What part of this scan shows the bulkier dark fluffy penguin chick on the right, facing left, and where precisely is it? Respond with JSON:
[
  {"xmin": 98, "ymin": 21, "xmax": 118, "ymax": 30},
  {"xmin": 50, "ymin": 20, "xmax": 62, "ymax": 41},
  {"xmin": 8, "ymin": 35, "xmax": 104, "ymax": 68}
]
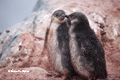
[{"xmin": 66, "ymin": 12, "xmax": 107, "ymax": 80}]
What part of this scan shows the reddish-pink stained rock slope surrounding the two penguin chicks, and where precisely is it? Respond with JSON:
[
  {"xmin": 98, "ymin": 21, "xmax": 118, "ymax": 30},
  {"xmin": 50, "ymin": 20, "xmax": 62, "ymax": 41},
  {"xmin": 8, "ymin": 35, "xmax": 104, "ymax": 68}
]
[{"xmin": 0, "ymin": 0, "xmax": 120, "ymax": 80}]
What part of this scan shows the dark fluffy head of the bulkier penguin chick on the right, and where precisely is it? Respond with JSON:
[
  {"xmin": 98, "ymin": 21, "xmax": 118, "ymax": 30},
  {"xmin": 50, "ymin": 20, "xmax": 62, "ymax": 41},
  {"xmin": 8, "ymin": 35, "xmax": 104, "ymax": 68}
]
[{"xmin": 66, "ymin": 12, "xmax": 89, "ymax": 25}]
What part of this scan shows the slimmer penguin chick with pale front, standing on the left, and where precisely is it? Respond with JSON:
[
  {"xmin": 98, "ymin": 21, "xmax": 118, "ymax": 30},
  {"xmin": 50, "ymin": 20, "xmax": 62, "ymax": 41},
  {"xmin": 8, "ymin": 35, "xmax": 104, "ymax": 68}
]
[{"xmin": 46, "ymin": 10, "xmax": 75, "ymax": 80}]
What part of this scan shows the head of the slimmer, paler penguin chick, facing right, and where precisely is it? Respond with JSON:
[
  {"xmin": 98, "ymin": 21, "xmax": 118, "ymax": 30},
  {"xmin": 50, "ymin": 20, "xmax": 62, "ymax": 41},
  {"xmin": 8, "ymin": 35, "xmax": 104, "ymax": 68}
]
[{"xmin": 52, "ymin": 10, "xmax": 66, "ymax": 24}]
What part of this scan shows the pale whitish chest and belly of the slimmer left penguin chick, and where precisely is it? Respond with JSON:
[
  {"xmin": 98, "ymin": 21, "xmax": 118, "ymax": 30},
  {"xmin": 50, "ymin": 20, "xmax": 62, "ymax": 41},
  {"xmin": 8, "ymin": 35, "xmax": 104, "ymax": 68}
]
[{"xmin": 48, "ymin": 23, "xmax": 63, "ymax": 72}]
